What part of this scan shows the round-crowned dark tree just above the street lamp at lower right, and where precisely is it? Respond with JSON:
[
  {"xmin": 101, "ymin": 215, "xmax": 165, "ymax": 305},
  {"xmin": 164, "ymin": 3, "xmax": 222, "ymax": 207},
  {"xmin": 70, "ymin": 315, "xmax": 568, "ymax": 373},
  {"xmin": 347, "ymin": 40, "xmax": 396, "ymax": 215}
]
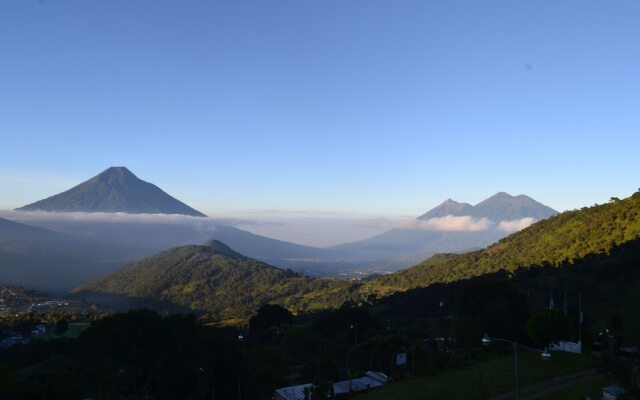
[{"xmin": 527, "ymin": 309, "xmax": 573, "ymax": 347}]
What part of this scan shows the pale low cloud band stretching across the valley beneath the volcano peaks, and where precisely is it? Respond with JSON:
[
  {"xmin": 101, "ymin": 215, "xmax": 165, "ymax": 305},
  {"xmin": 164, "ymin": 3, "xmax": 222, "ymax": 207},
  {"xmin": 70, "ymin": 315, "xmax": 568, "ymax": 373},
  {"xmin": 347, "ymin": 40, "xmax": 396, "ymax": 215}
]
[{"xmin": 0, "ymin": 210, "xmax": 536, "ymax": 247}]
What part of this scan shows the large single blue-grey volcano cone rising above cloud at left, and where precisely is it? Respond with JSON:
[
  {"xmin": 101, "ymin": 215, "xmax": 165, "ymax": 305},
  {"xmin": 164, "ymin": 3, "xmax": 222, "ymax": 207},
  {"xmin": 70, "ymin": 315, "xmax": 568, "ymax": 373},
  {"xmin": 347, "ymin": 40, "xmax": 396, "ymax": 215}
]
[{"xmin": 17, "ymin": 167, "xmax": 206, "ymax": 217}]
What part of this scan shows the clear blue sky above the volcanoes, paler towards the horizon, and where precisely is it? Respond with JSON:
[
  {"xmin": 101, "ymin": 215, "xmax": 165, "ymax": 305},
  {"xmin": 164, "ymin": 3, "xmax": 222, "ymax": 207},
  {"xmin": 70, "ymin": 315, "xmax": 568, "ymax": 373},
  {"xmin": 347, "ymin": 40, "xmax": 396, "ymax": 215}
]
[{"xmin": 0, "ymin": 0, "xmax": 640, "ymax": 222}]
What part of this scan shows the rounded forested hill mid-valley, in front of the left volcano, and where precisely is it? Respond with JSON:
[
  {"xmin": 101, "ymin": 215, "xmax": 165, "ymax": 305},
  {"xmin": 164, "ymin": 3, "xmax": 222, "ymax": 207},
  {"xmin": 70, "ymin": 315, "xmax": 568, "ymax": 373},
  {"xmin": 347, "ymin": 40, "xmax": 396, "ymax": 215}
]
[{"xmin": 75, "ymin": 241, "xmax": 355, "ymax": 322}]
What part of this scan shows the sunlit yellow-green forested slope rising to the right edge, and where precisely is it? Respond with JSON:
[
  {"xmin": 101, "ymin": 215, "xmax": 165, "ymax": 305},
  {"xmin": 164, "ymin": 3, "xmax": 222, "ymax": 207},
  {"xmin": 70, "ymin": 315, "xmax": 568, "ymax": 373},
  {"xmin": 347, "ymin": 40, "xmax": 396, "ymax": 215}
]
[{"xmin": 362, "ymin": 192, "xmax": 640, "ymax": 295}]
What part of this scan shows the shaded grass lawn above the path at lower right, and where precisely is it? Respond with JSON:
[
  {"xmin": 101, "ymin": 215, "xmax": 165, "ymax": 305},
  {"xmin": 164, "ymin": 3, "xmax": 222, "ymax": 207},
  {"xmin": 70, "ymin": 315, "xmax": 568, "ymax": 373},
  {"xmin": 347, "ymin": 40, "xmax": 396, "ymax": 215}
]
[{"xmin": 356, "ymin": 352, "xmax": 589, "ymax": 400}]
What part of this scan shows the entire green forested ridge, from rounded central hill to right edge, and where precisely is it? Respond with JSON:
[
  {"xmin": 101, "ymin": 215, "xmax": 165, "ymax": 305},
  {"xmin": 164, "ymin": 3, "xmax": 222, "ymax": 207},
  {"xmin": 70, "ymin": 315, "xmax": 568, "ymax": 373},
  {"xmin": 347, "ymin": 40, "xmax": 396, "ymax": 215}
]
[{"xmin": 77, "ymin": 193, "xmax": 640, "ymax": 323}]
